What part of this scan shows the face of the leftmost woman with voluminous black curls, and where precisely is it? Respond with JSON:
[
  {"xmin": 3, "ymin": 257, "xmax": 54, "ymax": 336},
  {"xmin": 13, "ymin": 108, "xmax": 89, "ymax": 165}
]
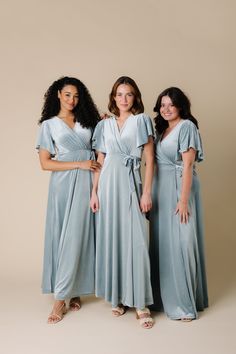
[{"xmin": 58, "ymin": 85, "xmax": 79, "ymax": 111}]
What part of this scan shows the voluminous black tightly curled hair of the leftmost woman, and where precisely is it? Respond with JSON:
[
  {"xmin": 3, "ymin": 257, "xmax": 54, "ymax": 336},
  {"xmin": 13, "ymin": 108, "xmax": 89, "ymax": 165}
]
[{"xmin": 39, "ymin": 76, "xmax": 100, "ymax": 128}]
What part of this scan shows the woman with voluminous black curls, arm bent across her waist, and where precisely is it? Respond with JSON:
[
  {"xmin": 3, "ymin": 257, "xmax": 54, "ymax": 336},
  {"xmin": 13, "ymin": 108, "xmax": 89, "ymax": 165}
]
[{"xmin": 37, "ymin": 77, "xmax": 100, "ymax": 324}]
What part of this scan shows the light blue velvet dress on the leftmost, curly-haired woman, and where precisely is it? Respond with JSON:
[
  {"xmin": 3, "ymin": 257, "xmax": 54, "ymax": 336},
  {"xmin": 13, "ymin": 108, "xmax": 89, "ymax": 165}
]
[{"xmin": 37, "ymin": 117, "xmax": 95, "ymax": 300}]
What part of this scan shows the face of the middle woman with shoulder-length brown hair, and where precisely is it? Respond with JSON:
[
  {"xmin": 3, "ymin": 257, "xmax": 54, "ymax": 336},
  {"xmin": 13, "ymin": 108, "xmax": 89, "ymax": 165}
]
[{"xmin": 114, "ymin": 84, "xmax": 135, "ymax": 113}]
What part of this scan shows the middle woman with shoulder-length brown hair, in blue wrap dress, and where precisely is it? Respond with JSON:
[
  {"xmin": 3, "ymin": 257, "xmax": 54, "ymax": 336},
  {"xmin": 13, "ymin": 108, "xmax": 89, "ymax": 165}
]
[{"xmin": 90, "ymin": 76, "xmax": 154, "ymax": 328}]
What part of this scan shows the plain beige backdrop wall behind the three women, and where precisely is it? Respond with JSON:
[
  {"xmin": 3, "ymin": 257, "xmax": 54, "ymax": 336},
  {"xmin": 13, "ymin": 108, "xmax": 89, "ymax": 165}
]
[{"xmin": 0, "ymin": 0, "xmax": 236, "ymax": 352}]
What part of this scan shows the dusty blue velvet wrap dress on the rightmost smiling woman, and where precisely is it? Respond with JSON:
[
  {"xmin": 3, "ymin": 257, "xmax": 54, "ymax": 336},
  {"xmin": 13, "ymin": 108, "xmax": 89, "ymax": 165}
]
[{"xmin": 150, "ymin": 120, "xmax": 208, "ymax": 319}]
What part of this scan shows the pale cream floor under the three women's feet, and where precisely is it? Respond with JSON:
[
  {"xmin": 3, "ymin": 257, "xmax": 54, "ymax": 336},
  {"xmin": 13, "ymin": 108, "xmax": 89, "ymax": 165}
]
[{"xmin": 0, "ymin": 278, "xmax": 236, "ymax": 354}]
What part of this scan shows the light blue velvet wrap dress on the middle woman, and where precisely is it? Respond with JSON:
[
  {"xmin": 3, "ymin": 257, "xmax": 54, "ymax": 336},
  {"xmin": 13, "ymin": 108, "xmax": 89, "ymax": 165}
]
[{"xmin": 93, "ymin": 114, "xmax": 153, "ymax": 309}]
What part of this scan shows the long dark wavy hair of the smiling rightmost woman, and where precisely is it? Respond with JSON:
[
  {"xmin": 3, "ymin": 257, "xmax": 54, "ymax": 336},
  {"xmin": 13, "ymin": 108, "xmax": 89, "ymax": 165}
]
[{"xmin": 153, "ymin": 87, "xmax": 198, "ymax": 134}]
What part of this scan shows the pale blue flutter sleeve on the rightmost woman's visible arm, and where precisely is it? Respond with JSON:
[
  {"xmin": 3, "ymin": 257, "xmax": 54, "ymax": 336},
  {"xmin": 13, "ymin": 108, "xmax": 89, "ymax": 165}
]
[{"xmin": 176, "ymin": 120, "xmax": 204, "ymax": 162}]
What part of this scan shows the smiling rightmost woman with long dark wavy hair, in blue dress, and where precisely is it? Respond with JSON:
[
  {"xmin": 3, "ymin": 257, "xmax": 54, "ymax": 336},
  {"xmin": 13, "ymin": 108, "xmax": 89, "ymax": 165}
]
[{"xmin": 150, "ymin": 87, "xmax": 208, "ymax": 321}]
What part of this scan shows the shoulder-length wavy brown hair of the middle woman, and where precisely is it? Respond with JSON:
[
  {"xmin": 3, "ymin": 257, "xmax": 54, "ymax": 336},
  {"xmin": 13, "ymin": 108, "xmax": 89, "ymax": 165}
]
[{"xmin": 108, "ymin": 76, "xmax": 144, "ymax": 116}]
